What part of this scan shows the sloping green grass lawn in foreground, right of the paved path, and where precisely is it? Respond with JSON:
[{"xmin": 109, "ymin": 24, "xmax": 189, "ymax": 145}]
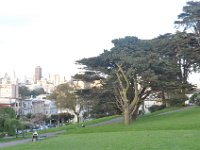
[{"xmin": 2, "ymin": 107, "xmax": 200, "ymax": 150}]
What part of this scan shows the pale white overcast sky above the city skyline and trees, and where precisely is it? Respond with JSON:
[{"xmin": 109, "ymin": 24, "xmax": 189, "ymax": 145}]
[{"xmin": 0, "ymin": 0, "xmax": 187, "ymax": 81}]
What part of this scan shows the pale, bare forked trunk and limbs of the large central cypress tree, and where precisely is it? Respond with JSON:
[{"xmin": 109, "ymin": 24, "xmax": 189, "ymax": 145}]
[{"xmin": 116, "ymin": 65, "xmax": 151, "ymax": 125}]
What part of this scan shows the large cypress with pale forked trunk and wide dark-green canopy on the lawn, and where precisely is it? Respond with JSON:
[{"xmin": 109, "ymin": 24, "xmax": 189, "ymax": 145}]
[{"xmin": 78, "ymin": 37, "xmax": 166, "ymax": 125}]
